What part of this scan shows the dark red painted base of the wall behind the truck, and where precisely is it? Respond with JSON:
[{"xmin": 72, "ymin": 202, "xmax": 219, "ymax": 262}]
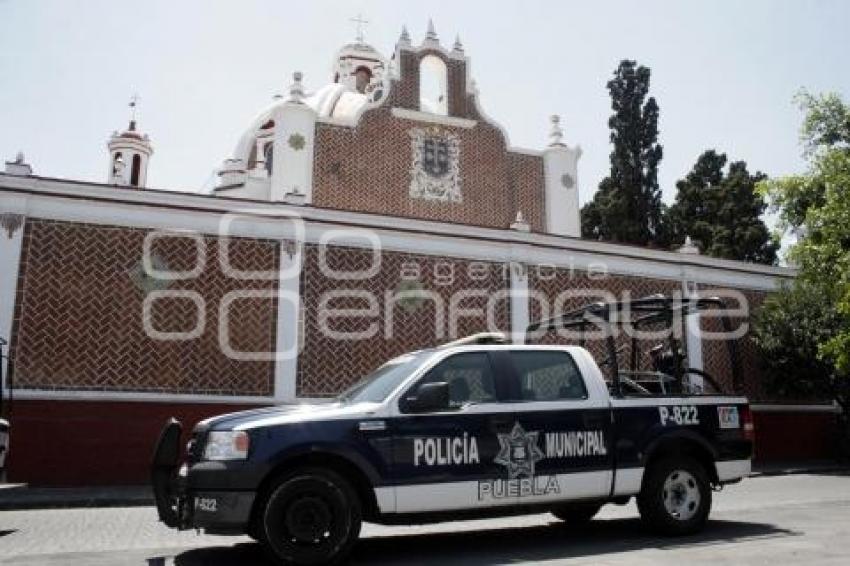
[{"xmin": 0, "ymin": 400, "xmax": 836, "ymax": 486}]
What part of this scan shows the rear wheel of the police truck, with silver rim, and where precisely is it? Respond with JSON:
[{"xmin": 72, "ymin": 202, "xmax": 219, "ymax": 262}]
[{"xmin": 637, "ymin": 456, "xmax": 711, "ymax": 535}]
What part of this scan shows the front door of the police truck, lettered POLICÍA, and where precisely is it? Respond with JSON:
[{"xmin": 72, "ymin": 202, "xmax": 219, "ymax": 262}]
[{"xmin": 392, "ymin": 351, "xmax": 512, "ymax": 513}]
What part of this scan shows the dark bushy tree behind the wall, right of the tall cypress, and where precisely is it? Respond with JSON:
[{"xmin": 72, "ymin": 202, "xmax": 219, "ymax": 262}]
[{"xmin": 667, "ymin": 149, "xmax": 779, "ymax": 264}]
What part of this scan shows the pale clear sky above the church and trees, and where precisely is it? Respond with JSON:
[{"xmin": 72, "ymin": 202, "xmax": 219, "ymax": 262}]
[{"xmin": 0, "ymin": 0, "xmax": 850, "ymax": 201}]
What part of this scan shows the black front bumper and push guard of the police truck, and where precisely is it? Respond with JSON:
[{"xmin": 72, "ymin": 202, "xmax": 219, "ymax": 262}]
[{"xmin": 151, "ymin": 419, "xmax": 255, "ymax": 534}]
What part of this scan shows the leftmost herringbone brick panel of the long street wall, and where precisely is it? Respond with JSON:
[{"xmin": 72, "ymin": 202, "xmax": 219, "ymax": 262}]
[{"xmin": 13, "ymin": 220, "xmax": 278, "ymax": 395}]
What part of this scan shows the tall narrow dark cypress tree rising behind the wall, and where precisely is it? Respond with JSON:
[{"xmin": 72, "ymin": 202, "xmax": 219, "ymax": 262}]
[{"xmin": 581, "ymin": 60, "xmax": 666, "ymax": 245}]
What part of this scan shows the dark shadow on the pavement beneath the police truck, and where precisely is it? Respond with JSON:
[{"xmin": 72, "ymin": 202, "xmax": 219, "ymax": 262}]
[{"xmin": 174, "ymin": 519, "xmax": 800, "ymax": 566}]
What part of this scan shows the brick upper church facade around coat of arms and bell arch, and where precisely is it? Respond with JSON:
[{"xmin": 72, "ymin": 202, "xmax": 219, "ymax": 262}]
[{"xmin": 313, "ymin": 46, "xmax": 545, "ymax": 232}]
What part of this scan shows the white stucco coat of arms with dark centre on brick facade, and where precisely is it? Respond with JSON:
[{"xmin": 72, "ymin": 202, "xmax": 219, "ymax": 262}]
[{"xmin": 410, "ymin": 127, "xmax": 463, "ymax": 202}]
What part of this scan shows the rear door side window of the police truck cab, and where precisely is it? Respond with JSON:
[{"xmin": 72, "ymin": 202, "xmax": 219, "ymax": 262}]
[{"xmin": 511, "ymin": 350, "xmax": 587, "ymax": 401}]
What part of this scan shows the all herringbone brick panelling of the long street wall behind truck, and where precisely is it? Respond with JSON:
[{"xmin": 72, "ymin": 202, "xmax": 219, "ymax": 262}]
[{"xmin": 4, "ymin": 220, "xmax": 780, "ymax": 400}]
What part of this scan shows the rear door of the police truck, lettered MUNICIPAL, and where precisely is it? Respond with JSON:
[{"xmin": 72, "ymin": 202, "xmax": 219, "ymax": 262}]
[{"xmin": 497, "ymin": 349, "xmax": 613, "ymax": 506}]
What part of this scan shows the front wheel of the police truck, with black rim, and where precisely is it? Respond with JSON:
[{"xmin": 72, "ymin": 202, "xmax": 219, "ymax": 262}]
[{"xmin": 262, "ymin": 468, "xmax": 361, "ymax": 564}]
